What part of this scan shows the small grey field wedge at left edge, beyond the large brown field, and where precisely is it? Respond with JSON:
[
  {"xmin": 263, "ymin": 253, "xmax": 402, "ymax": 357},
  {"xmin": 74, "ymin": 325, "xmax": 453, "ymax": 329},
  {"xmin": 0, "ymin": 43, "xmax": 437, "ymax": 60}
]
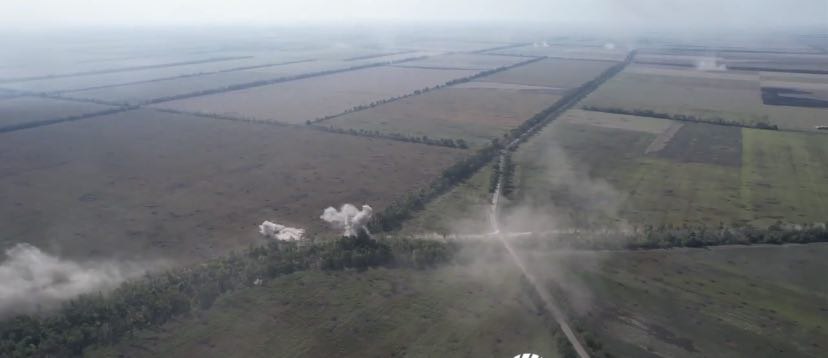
[{"xmin": 0, "ymin": 97, "xmax": 113, "ymax": 131}]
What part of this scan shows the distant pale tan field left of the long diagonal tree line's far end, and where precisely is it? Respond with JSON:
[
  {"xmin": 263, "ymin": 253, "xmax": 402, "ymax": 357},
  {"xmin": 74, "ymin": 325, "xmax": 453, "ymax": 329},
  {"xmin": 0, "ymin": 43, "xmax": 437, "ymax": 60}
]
[{"xmin": 480, "ymin": 59, "xmax": 615, "ymax": 88}]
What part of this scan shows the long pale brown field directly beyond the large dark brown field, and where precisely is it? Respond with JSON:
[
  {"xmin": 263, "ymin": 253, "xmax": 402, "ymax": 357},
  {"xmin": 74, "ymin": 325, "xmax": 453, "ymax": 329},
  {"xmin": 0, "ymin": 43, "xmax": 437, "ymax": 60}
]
[{"xmin": 151, "ymin": 67, "xmax": 476, "ymax": 123}]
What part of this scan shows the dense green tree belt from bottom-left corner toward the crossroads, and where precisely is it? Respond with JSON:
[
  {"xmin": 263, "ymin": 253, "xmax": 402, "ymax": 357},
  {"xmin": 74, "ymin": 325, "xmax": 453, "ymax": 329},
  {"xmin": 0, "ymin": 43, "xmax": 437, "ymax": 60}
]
[{"xmin": 0, "ymin": 232, "xmax": 456, "ymax": 358}]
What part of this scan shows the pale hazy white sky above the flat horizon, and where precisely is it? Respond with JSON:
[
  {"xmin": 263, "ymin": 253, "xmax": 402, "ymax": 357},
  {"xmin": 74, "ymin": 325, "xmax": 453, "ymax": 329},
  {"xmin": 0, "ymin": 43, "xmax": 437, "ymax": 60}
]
[{"xmin": 0, "ymin": 0, "xmax": 828, "ymax": 28}]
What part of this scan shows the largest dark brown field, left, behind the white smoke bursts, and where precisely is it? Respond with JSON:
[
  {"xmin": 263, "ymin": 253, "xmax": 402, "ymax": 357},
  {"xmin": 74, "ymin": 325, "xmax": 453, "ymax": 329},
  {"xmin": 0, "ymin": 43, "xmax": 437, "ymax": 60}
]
[{"xmin": 0, "ymin": 110, "xmax": 466, "ymax": 262}]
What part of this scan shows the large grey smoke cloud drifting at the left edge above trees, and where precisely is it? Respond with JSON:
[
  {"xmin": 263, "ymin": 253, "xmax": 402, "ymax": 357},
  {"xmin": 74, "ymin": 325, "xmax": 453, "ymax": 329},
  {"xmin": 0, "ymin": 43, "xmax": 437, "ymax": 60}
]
[{"xmin": 0, "ymin": 244, "xmax": 150, "ymax": 316}]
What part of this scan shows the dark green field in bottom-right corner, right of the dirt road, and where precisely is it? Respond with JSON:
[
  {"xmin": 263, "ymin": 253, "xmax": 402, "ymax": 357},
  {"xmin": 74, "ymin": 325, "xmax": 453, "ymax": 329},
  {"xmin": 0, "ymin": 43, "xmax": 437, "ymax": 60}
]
[{"xmin": 556, "ymin": 244, "xmax": 828, "ymax": 357}]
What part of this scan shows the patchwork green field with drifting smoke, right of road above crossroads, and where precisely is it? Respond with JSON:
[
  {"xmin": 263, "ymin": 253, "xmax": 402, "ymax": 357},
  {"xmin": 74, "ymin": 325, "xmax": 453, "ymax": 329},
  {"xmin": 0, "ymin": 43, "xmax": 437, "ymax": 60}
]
[{"xmin": 507, "ymin": 111, "xmax": 828, "ymax": 226}]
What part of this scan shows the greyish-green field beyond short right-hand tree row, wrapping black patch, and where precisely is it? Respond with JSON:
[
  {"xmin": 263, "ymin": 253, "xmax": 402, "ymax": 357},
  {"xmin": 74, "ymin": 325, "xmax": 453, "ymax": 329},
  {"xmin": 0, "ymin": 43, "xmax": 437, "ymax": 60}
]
[{"xmin": 585, "ymin": 65, "xmax": 828, "ymax": 131}]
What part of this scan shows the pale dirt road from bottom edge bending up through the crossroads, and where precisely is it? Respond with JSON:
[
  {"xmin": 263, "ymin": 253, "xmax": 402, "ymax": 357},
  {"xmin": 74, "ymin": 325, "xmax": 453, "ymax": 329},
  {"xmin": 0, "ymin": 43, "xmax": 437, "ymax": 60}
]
[{"xmin": 489, "ymin": 153, "xmax": 589, "ymax": 358}]
